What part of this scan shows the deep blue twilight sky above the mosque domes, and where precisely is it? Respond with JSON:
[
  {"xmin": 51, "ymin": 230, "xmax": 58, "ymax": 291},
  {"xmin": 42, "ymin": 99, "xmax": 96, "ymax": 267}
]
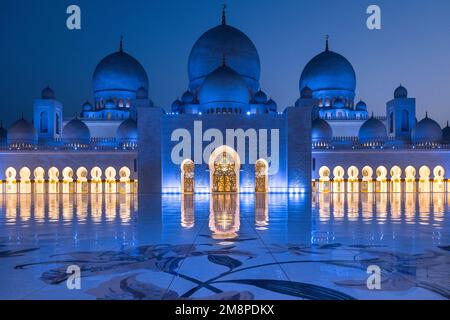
[{"xmin": 0, "ymin": 0, "xmax": 450, "ymax": 126}]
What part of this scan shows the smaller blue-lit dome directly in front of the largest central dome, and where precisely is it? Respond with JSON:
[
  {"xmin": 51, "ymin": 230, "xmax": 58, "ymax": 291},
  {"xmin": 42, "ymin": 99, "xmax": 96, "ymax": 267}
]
[{"xmin": 199, "ymin": 65, "xmax": 250, "ymax": 104}]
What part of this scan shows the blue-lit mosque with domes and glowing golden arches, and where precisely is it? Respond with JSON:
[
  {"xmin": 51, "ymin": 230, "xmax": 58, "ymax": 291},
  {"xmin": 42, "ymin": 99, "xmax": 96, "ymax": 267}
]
[{"xmin": 0, "ymin": 12, "xmax": 450, "ymax": 194}]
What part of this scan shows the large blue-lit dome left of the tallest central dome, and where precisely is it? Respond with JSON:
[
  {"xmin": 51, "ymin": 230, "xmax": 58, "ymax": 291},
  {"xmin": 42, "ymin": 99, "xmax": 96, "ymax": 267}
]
[{"xmin": 92, "ymin": 45, "xmax": 148, "ymax": 98}]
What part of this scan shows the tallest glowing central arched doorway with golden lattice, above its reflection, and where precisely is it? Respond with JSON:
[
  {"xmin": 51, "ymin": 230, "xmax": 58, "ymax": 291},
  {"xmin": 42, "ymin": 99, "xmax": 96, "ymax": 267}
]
[{"xmin": 209, "ymin": 146, "xmax": 241, "ymax": 192}]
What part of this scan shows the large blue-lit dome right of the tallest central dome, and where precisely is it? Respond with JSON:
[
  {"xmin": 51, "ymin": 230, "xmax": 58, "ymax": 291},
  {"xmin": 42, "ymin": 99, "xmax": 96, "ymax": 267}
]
[{"xmin": 300, "ymin": 50, "xmax": 356, "ymax": 93}]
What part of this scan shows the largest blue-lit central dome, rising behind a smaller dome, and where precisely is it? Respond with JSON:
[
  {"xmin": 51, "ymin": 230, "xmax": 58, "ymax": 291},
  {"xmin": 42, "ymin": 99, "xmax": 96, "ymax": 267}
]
[{"xmin": 188, "ymin": 22, "xmax": 261, "ymax": 92}]
